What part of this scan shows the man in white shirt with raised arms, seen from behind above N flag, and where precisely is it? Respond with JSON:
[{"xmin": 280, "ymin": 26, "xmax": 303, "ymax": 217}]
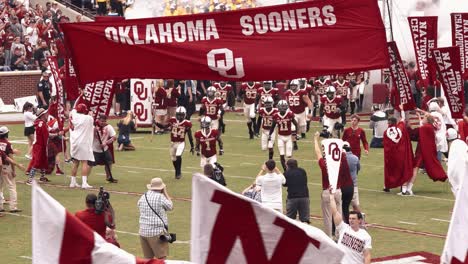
[{"xmin": 256, "ymin": 159, "xmax": 286, "ymax": 212}]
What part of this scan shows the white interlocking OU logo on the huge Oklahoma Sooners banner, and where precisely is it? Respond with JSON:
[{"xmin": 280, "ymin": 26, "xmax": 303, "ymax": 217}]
[{"xmin": 206, "ymin": 48, "xmax": 245, "ymax": 78}]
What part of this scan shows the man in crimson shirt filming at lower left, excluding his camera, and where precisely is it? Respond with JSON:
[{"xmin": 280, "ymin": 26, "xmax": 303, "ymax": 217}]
[{"xmin": 75, "ymin": 193, "xmax": 115, "ymax": 239}]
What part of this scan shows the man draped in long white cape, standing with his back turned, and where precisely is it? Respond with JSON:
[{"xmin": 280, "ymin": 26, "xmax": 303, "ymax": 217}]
[{"xmin": 70, "ymin": 104, "xmax": 94, "ymax": 189}]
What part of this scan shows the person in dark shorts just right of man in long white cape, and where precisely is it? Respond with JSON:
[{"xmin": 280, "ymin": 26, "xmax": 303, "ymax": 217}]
[{"xmin": 92, "ymin": 114, "xmax": 117, "ymax": 183}]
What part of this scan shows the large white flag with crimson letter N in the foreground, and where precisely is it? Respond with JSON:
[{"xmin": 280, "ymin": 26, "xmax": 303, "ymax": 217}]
[{"xmin": 190, "ymin": 174, "xmax": 343, "ymax": 264}]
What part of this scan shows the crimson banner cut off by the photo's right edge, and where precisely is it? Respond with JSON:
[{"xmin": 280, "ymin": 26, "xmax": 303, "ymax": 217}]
[{"xmin": 451, "ymin": 13, "xmax": 468, "ymax": 80}]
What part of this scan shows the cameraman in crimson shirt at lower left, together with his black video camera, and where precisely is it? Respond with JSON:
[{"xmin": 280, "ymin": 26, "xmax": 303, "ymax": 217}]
[{"xmin": 75, "ymin": 191, "xmax": 115, "ymax": 238}]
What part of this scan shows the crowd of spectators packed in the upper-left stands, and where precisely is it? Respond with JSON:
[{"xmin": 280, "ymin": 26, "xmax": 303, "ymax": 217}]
[{"xmin": 0, "ymin": 0, "xmax": 70, "ymax": 71}]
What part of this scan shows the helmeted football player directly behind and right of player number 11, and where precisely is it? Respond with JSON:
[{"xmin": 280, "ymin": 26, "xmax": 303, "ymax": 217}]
[{"xmin": 284, "ymin": 79, "xmax": 312, "ymax": 150}]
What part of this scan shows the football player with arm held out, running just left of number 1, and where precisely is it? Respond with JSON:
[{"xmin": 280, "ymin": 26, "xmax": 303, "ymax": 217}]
[{"xmin": 156, "ymin": 106, "xmax": 194, "ymax": 179}]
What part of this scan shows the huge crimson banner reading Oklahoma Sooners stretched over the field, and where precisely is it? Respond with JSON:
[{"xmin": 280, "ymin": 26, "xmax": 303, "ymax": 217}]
[{"xmin": 61, "ymin": 0, "xmax": 388, "ymax": 83}]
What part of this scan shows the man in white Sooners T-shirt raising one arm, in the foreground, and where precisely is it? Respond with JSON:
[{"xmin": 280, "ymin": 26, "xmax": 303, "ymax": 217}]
[{"xmin": 329, "ymin": 188, "xmax": 372, "ymax": 264}]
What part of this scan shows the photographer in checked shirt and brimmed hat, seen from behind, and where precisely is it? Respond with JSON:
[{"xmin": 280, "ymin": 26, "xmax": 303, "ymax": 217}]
[{"xmin": 138, "ymin": 178, "xmax": 175, "ymax": 259}]
